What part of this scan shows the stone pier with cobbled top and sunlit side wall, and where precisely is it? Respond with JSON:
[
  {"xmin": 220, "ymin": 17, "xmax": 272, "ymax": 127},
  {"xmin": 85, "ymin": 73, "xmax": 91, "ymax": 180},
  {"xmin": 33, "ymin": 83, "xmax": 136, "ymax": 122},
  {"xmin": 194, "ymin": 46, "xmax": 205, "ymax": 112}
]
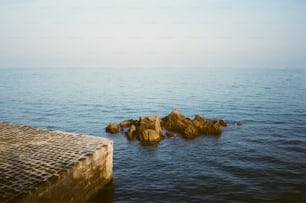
[{"xmin": 0, "ymin": 123, "xmax": 113, "ymax": 202}]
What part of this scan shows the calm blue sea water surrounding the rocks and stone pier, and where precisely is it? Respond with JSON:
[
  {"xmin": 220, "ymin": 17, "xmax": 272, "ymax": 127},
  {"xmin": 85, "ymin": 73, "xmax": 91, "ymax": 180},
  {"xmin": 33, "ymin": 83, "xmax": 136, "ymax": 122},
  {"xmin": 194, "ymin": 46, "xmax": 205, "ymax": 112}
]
[{"xmin": 0, "ymin": 68, "xmax": 306, "ymax": 202}]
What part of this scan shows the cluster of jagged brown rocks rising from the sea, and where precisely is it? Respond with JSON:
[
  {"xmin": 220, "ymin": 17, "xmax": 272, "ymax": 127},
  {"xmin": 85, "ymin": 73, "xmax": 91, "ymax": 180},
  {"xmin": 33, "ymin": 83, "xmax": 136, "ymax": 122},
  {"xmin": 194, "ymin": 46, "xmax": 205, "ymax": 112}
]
[{"xmin": 105, "ymin": 109, "xmax": 227, "ymax": 142}]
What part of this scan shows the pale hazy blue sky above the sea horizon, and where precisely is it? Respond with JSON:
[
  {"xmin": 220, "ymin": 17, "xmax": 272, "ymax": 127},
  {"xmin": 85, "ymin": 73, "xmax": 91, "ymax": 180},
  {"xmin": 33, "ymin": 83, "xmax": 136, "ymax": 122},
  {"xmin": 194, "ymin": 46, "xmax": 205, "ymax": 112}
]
[{"xmin": 0, "ymin": 0, "xmax": 306, "ymax": 67}]
